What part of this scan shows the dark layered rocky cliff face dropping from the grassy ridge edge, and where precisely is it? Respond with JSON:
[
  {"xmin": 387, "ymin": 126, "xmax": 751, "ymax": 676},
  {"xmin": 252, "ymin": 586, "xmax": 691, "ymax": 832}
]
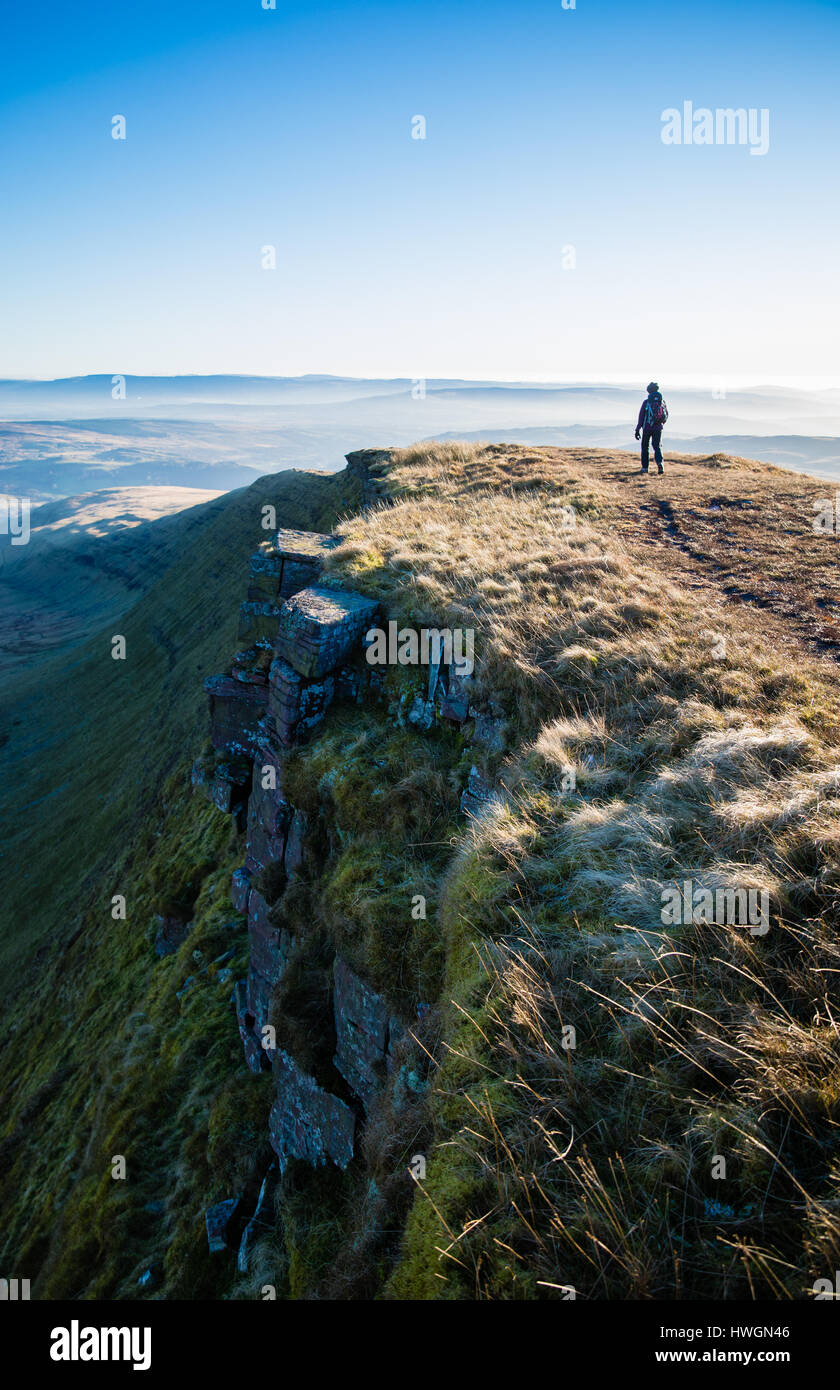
[{"xmin": 193, "ymin": 450, "xmax": 503, "ymax": 1269}]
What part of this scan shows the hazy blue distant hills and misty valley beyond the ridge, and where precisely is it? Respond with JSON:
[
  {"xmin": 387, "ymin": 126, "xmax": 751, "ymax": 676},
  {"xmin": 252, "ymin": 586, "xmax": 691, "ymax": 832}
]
[{"xmin": 0, "ymin": 374, "xmax": 840, "ymax": 502}]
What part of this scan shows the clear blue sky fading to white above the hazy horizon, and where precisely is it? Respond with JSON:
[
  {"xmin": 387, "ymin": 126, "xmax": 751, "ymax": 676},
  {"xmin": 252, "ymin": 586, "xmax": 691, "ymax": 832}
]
[{"xmin": 0, "ymin": 0, "xmax": 840, "ymax": 384}]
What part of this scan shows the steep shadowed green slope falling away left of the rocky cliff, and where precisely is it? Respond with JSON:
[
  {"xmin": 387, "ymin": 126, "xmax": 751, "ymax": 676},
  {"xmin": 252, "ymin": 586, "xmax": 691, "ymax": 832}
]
[{"xmin": 0, "ymin": 473, "xmax": 357, "ymax": 1297}]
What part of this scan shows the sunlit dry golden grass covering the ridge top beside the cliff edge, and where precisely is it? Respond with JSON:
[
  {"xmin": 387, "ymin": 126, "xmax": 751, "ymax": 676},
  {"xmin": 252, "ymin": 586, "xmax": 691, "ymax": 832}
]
[{"xmin": 332, "ymin": 445, "xmax": 840, "ymax": 1298}]
